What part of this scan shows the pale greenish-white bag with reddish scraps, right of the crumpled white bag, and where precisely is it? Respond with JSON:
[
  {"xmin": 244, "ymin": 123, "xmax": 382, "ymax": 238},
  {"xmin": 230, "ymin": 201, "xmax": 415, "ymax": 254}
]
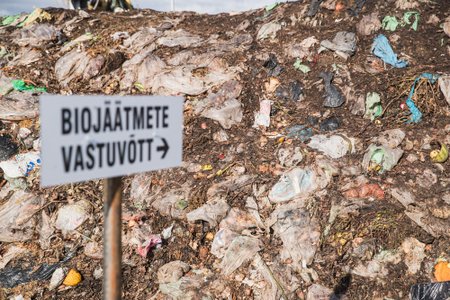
[{"xmin": 362, "ymin": 144, "xmax": 403, "ymax": 173}]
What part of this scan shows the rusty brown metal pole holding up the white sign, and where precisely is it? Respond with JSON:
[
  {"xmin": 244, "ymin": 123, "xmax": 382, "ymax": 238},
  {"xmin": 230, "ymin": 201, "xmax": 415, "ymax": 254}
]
[{"xmin": 103, "ymin": 177, "xmax": 122, "ymax": 300}]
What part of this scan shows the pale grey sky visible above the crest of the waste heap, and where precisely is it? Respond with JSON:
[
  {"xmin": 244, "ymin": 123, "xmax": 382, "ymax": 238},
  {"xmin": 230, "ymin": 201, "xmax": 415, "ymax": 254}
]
[{"xmin": 0, "ymin": 0, "xmax": 294, "ymax": 16}]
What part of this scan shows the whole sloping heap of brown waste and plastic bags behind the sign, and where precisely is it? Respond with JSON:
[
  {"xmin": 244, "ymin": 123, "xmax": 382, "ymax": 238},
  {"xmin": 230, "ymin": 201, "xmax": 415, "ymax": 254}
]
[{"xmin": 0, "ymin": 0, "xmax": 450, "ymax": 300}]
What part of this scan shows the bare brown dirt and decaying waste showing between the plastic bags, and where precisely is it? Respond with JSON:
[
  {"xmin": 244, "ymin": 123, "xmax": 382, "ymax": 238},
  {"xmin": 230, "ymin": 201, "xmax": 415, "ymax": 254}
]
[{"xmin": 0, "ymin": 0, "xmax": 450, "ymax": 299}]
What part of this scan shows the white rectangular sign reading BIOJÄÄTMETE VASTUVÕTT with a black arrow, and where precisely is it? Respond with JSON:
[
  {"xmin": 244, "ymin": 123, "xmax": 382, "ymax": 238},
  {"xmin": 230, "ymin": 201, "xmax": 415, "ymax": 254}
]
[{"xmin": 40, "ymin": 95, "xmax": 183, "ymax": 186}]
